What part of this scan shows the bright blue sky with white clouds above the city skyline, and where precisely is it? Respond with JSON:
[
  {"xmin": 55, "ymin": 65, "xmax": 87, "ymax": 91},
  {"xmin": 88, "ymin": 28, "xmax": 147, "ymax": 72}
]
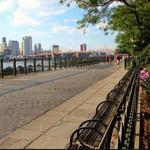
[{"xmin": 0, "ymin": 0, "xmax": 116, "ymax": 50}]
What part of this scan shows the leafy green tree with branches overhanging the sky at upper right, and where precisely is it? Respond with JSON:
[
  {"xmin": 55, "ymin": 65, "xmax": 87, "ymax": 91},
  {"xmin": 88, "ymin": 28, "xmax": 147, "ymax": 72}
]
[{"xmin": 60, "ymin": 0, "xmax": 150, "ymax": 54}]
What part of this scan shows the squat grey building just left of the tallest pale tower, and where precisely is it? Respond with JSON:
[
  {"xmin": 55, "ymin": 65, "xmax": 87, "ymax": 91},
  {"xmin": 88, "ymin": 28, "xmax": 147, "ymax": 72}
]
[{"xmin": 8, "ymin": 41, "xmax": 19, "ymax": 56}]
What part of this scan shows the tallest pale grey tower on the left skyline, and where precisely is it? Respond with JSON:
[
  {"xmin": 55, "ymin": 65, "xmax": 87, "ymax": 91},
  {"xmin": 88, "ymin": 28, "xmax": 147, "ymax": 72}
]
[{"xmin": 22, "ymin": 36, "xmax": 32, "ymax": 56}]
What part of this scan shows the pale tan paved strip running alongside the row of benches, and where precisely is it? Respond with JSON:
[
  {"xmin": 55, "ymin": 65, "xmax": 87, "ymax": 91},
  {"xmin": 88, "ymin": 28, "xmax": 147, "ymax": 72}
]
[{"xmin": 0, "ymin": 65, "xmax": 126, "ymax": 149}]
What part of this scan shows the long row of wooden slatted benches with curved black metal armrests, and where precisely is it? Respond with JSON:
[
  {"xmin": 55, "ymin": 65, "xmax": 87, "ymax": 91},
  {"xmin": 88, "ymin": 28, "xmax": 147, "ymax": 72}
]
[{"xmin": 68, "ymin": 67, "xmax": 139, "ymax": 150}]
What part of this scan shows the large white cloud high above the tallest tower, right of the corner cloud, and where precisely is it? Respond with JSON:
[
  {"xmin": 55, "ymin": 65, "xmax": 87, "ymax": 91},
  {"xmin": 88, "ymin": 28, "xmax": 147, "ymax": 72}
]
[{"xmin": 11, "ymin": 0, "xmax": 66, "ymax": 26}]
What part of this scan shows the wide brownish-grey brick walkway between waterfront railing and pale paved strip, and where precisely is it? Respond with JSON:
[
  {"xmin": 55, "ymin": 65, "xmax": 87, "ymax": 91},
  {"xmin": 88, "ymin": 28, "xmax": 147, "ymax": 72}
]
[{"xmin": 0, "ymin": 64, "xmax": 116, "ymax": 138}]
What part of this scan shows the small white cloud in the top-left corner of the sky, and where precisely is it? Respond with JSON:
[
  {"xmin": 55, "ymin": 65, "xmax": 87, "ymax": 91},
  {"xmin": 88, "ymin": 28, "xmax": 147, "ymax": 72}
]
[{"xmin": 0, "ymin": 0, "xmax": 15, "ymax": 12}]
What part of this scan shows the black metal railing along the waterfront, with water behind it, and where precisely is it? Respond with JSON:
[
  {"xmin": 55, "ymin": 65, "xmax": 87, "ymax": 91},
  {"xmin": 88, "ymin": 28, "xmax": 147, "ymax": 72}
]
[{"xmin": 0, "ymin": 56, "xmax": 104, "ymax": 78}]
